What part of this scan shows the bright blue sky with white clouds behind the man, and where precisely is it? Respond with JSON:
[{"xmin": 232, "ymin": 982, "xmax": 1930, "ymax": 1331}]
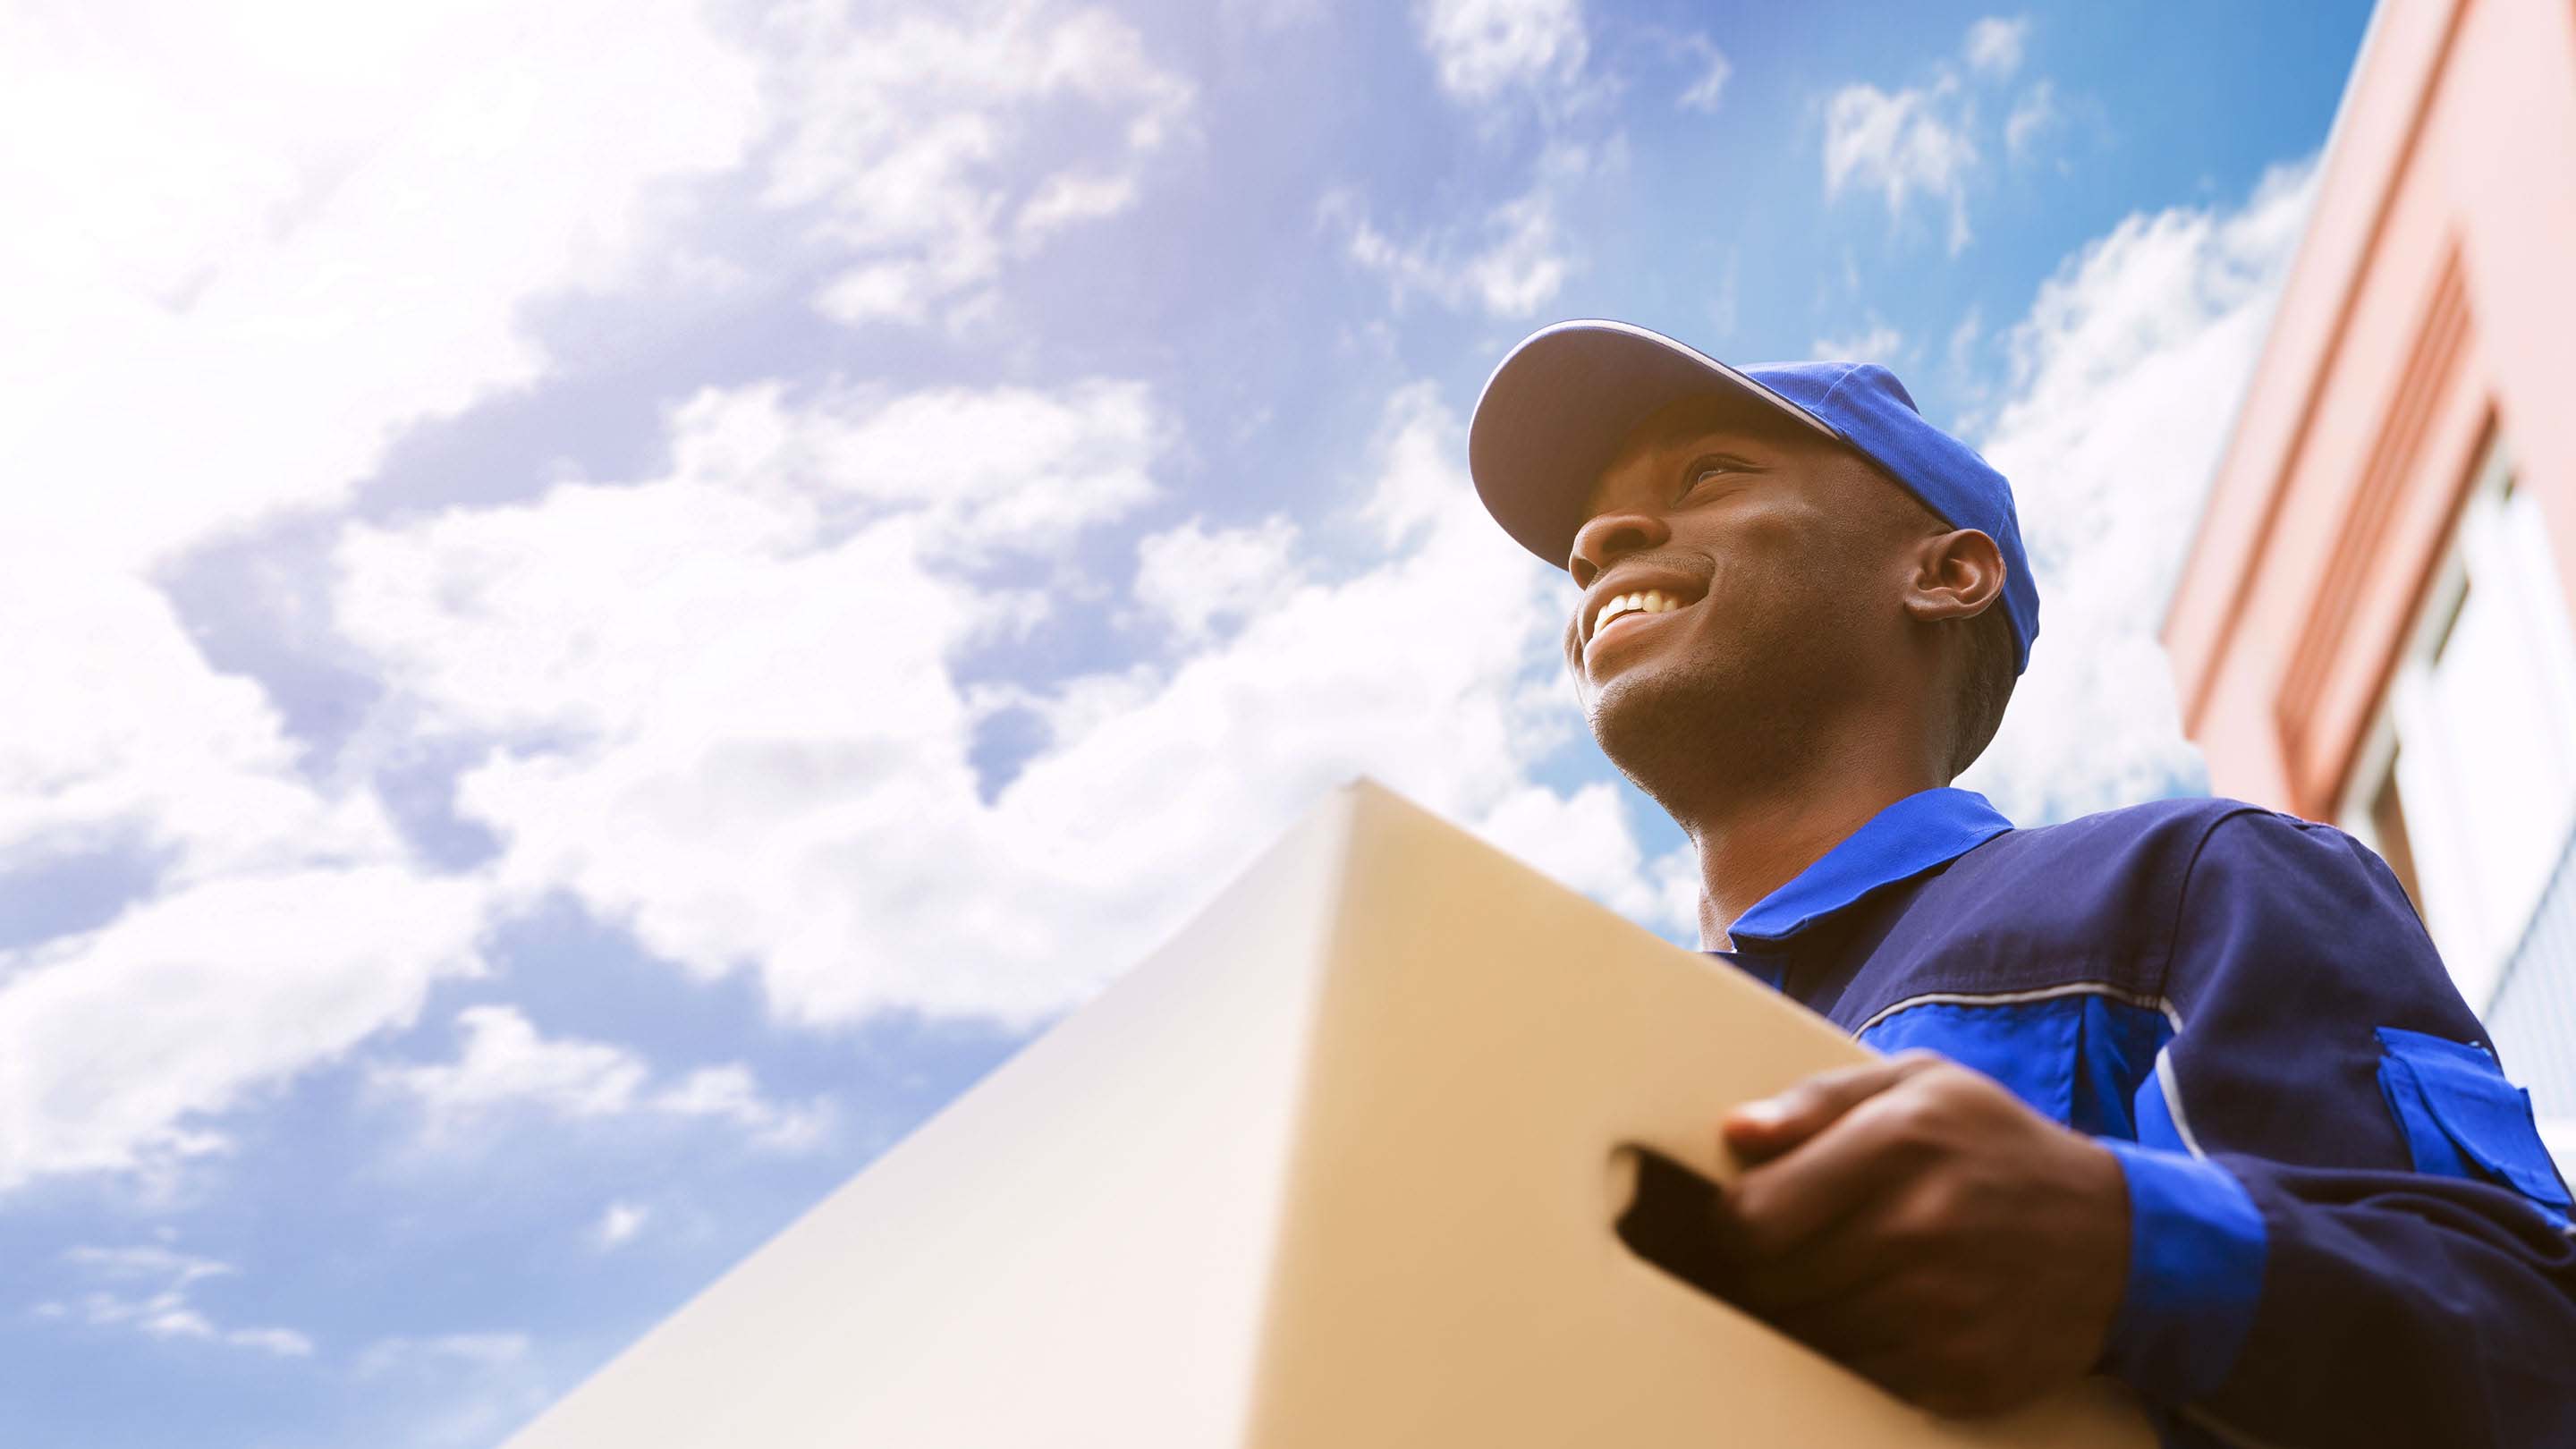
[{"xmin": 0, "ymin": 0, "xmax": 2368, "ymax": 1446}]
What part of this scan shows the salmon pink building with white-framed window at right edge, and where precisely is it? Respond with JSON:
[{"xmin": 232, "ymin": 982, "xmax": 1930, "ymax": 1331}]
[{"xmin": 2164, "ymin": 0, "xmax": 2576, "ymax": 1129}]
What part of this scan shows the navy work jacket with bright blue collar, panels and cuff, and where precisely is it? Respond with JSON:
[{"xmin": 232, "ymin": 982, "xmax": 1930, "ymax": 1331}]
[{"xmin": 1721, "ymin": 789, "xmax": 2576, "ymax": 1449}]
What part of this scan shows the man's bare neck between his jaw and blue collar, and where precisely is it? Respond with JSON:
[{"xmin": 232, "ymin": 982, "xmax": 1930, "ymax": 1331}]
[{"xmin": 1674, "ymin": 768, "xmax": 1943, "ymax": 949}]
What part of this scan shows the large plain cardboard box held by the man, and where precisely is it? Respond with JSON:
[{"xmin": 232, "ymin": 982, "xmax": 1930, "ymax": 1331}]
[{"xmin": 513, "ymin": 781, "xmax": 2154, "ymax": 1449}]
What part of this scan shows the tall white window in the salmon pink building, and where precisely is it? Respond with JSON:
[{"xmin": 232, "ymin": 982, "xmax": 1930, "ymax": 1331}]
[{"xmin": 2342, "ymin": 433, "xmax": 2576, "ymax": 1011}]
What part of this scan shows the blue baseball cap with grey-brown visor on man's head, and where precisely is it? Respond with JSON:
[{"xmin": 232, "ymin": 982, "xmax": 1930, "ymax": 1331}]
[{"xmin": 1466, "ymin": 319, "xmax": 2040, "ymax": 673}]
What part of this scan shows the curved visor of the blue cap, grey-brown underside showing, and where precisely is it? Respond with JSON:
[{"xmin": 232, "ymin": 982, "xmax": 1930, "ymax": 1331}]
[{"xmin": 1466, "ymin": 319, "xmax": 1842, "ymax": 567}]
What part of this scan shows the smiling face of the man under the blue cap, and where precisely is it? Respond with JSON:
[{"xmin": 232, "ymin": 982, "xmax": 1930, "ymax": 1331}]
[{"xmin": 1566, "ymin": 400, "xmax": 1940, "ymax": 794}]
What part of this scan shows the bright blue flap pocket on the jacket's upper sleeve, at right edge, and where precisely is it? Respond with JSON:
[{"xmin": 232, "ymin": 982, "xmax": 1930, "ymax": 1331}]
[{"xmin": 2380, "ymin": 1026, "xmax": 2571, "ymax": 1227}]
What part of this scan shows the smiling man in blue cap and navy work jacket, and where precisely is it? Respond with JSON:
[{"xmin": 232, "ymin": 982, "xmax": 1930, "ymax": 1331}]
[{"xmin": 1469, "ymin": 322, "xmax": 2576, "ymax": 1446}]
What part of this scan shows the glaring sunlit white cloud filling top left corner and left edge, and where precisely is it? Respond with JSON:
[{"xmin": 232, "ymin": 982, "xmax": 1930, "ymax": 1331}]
[{"xmin": 0, "ymin": 0, "xmax": 760, "ymax": 1196}]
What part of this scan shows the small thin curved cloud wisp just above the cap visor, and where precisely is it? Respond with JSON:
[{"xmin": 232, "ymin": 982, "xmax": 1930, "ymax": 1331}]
[{"xmin": 1324, "ymin": 144, "xmax": 1592, "ymax": 318}]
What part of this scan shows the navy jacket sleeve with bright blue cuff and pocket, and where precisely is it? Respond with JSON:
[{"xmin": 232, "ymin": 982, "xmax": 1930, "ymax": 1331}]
[{"xmin": 2107, "ymin": 807, "xmax": 2576, "ymax": 1449}]
